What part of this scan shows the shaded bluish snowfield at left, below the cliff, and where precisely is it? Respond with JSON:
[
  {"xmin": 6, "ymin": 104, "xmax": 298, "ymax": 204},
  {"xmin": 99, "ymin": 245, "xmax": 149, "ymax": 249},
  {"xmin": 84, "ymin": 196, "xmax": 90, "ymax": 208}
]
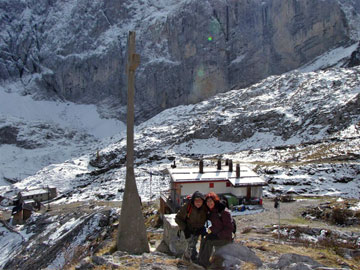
[{"xmin": 0, "ymin": 81, "xmax": 125, "ymax": 190}]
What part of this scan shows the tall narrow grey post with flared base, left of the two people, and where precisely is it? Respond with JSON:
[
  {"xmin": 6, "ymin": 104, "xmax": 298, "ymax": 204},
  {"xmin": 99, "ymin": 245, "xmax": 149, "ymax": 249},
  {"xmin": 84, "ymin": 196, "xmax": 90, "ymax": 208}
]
[{"xmin": 117, "ymin": 32, "xmax": 149, "ymax": 254}]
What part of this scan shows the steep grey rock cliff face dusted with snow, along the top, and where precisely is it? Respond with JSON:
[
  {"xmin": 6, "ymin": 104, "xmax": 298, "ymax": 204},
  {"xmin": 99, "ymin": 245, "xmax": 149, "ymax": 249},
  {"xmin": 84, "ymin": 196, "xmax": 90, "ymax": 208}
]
[{"xmin": 0, "ymin": 0, "xmax": 356, "ymax": 121}]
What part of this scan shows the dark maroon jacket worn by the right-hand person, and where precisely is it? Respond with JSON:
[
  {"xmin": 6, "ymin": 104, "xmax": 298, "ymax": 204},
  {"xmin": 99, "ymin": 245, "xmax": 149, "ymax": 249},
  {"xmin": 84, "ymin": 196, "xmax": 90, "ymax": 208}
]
[{"xmin": 208, "ymin": 203, "xmax": 233, "ymax": 241}]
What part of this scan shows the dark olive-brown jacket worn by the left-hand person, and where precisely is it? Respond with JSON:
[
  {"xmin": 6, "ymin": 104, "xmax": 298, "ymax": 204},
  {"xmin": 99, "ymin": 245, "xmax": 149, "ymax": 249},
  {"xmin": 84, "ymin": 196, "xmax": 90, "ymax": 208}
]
[{"xmin": 175, "ymin": 195, "xmax": 207, "ymax": 234}]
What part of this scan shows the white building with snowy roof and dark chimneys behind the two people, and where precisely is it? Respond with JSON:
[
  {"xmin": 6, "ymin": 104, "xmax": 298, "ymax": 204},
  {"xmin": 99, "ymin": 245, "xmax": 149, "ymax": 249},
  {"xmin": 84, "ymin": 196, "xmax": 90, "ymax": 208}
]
[{"xmin": 160, "ymin": 160, "xmax": 267, "ymax": 214}]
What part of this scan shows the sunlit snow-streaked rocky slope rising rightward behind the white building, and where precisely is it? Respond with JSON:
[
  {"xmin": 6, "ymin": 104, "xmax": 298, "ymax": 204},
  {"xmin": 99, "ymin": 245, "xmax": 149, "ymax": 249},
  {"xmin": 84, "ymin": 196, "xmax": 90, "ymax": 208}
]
[{"xmin": 1, "ymin": 67, "xmax": 360, "ymax": 201}]
